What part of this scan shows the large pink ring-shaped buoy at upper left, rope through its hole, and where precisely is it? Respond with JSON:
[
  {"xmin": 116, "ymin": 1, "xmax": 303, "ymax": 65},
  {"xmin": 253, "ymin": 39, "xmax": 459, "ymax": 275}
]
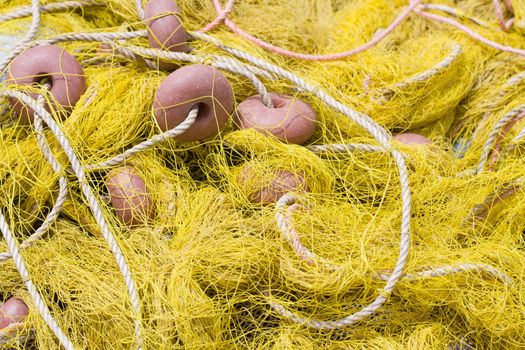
[{"xmin": 7, "ymin": 45, "xmax": 86, "ymax": 124}]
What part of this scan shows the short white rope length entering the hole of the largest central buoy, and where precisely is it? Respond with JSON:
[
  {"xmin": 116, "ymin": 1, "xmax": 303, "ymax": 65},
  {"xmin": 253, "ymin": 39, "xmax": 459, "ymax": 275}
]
[{"xmin": 85, "ymin": 105, "xmax": 199, "ymax": 171}]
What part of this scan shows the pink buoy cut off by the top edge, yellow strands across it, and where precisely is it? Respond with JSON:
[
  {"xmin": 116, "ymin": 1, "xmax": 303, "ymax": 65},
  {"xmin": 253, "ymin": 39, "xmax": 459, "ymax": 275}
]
[{"xmin": 144, "ymin": 0, "xmax": 190, "ymax": 52}]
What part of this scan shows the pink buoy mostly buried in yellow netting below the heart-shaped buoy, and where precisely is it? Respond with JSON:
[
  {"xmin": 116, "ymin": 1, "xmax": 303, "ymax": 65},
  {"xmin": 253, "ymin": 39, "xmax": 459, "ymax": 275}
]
[{"xmin": 238, "ymin": 165, "xmax": 308, "ymax": 205}]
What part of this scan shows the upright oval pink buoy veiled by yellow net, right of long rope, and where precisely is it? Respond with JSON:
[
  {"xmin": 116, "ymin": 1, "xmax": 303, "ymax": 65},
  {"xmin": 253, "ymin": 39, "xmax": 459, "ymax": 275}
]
[{"xmin": 106, "ymin": 166, "xmax": 154, "ymax": 226}]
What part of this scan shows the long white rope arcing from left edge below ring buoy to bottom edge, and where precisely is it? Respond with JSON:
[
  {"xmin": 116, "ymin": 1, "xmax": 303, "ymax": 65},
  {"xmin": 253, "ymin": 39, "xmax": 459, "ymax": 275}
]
[{"xmin": 2, "ymin": 90, "xmax": 143, "ymax": 349}]
